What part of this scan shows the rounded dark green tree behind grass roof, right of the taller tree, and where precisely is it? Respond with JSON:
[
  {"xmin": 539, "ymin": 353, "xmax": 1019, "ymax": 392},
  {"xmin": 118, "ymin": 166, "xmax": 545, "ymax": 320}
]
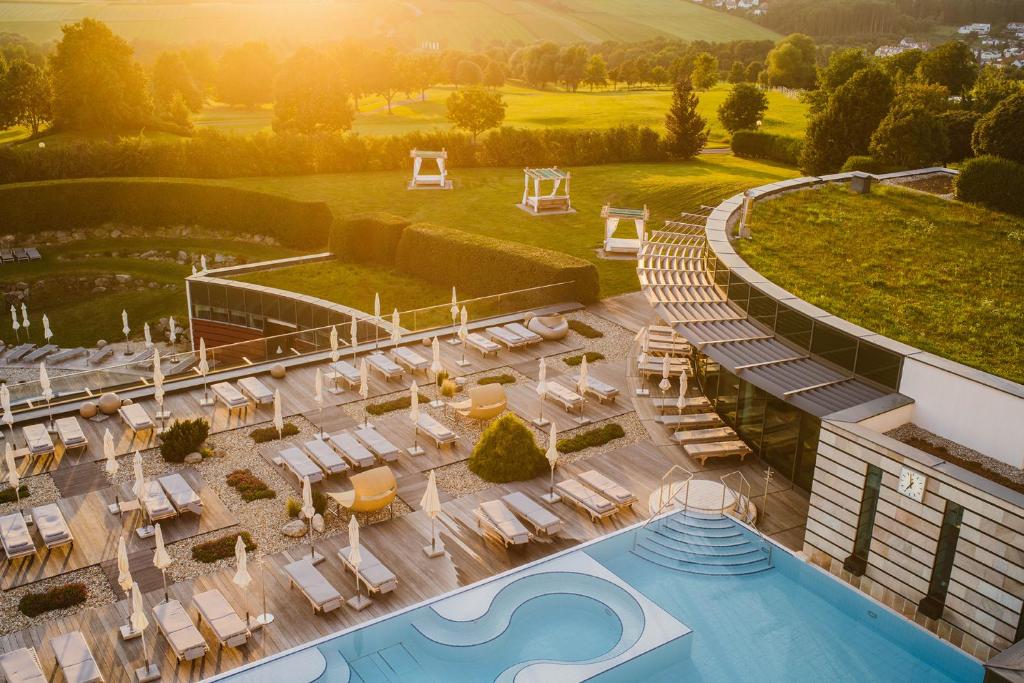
[{"xmin": 869, "ymin": 103, "xmax": 949, "ymax": 169}]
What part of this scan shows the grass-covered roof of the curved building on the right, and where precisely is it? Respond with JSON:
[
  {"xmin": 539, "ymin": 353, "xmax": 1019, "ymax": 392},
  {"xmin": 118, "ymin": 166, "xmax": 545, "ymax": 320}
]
[{"xmin": 737, "ymin": 187, "xmax": 1024, "ymax": 382}]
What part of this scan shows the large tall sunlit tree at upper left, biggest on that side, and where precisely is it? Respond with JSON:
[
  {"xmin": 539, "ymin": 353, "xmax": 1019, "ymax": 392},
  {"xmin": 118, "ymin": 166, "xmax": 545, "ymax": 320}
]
[{"xmin": 50, "ymin": 18, "xmax": 153, "ymax": 133}]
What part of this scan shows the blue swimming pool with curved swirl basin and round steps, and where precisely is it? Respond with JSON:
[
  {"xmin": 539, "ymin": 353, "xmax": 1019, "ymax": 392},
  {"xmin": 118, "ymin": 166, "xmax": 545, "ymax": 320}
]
[{"xmin": 214, "ymin": 515, "xmax": 983, "ymax": 683}]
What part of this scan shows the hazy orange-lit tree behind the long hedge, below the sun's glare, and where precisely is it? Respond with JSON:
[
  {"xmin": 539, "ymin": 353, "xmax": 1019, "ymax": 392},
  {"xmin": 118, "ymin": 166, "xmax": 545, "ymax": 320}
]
[{"xmin": 273, "ymin": 47, "xmax": 355, "ymax": 133}]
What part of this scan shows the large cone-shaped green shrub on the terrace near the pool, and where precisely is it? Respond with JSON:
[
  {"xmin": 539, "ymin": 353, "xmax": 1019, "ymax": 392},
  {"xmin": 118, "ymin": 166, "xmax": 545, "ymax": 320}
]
[{"xmin": 469, "ymin": 414, "xmax": 548, "ymax": 483}]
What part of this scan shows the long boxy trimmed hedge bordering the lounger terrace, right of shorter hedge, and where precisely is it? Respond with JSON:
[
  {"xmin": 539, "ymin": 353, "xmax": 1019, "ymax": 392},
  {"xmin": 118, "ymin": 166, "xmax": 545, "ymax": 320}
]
[{"xmin": 395, "ymin": 223, "xmax": 600, "ymax": 303}]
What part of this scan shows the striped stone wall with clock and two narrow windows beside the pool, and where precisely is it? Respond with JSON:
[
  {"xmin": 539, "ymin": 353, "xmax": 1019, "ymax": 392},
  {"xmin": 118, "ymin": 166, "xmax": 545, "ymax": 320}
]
[{"xmin": 804, "ymin": 420, "xmax": 1024, "ymax": 660}]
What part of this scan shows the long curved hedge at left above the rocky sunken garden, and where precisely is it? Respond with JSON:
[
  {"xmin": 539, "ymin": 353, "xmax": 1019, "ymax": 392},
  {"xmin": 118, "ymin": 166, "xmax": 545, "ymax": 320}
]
[{"xmin": 0, "ymin": 178, "xmax": 333, "ymax": 250}]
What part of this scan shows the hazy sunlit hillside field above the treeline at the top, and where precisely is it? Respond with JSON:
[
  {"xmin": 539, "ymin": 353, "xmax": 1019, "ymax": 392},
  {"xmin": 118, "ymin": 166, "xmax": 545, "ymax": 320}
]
[{"xmin": 0, "ymin": 0, "xmax": 779, "ymax": 49}]
